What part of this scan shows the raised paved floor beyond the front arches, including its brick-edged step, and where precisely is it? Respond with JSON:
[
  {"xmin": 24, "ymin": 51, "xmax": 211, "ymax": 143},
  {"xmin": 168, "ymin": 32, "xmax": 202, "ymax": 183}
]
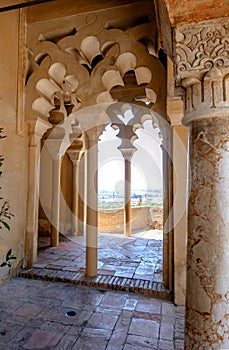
[{"xmin": 20, "ymin": 230, "xmax": 171, "ymax": 300}]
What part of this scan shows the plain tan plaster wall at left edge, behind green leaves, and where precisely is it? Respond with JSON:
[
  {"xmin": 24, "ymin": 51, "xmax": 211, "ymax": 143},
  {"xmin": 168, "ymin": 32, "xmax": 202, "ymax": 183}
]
[{"xmin": 0, "ymin": 11, "xmax": 27, "ymax": 281}]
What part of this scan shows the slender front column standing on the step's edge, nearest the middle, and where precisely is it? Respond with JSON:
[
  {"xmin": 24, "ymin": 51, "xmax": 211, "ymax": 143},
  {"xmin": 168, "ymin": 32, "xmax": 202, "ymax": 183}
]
[{"xmin": 86, "ymin": 128, "xmax": 98, "ymax": 277}]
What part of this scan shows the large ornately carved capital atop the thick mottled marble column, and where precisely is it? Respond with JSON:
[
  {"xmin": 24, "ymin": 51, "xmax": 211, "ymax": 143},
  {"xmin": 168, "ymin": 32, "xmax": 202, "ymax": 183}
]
[{"xmin": 174, "ymin": 17, "xmax": 229, "ymax": 125}]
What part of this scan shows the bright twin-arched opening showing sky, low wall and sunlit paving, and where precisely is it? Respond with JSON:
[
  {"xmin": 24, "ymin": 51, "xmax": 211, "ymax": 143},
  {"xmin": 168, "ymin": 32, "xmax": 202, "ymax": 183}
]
[{"xmin": 98, "ymin": 120, "xmax": 163, "ymax": 282}]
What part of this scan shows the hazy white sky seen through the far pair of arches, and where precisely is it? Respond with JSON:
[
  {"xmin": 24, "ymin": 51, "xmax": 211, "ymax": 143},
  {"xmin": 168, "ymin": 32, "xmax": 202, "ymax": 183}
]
[{"xmin": 98, "ymin": 121, "xmax": 162, "ymax": 191}]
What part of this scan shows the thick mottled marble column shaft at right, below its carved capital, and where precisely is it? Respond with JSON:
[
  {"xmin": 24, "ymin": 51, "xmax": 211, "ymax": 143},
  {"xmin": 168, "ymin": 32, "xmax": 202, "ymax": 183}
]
[{"xmin": 185, "ymin": 117, "xmax": 229, "ymax": 350}]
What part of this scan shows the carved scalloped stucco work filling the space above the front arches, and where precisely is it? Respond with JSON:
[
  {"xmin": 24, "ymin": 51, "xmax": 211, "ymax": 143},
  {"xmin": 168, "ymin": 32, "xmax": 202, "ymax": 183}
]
[{"xmin": 26, "ymin": 19, "xmax": 166, "ymax": 131}]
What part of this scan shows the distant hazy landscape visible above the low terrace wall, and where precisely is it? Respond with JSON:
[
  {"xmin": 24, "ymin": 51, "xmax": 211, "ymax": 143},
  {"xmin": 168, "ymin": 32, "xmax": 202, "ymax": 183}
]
[{"xmin": 98, "ymin": 189, "xmax": 163, "ymax": 209}]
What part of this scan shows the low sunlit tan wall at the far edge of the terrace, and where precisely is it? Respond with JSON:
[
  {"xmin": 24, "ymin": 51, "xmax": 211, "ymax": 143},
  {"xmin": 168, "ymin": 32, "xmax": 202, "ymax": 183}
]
[{"xmin": 99, "ymin": 207, "xmax": 163, "ymax": 233}]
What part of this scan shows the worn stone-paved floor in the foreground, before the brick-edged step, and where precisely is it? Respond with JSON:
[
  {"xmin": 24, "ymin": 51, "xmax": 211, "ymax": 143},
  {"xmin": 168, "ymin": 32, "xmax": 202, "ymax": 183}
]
[{"xmin": 0, "ymin": 278, "xmax": 184, "ymax": 350}]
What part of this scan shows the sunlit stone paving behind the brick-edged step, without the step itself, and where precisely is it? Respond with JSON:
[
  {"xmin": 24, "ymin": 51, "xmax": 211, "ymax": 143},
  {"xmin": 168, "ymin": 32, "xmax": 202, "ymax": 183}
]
[{"xmin": 37, "ymin": 230, "xmax": 162, "ymax": 282}]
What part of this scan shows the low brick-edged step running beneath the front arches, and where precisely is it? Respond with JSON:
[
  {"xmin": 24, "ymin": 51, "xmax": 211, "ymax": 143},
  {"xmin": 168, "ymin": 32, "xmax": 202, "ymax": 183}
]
[{"xmin": 18, "ymin": 267, "xmax": 172, "ymax": 300}]
